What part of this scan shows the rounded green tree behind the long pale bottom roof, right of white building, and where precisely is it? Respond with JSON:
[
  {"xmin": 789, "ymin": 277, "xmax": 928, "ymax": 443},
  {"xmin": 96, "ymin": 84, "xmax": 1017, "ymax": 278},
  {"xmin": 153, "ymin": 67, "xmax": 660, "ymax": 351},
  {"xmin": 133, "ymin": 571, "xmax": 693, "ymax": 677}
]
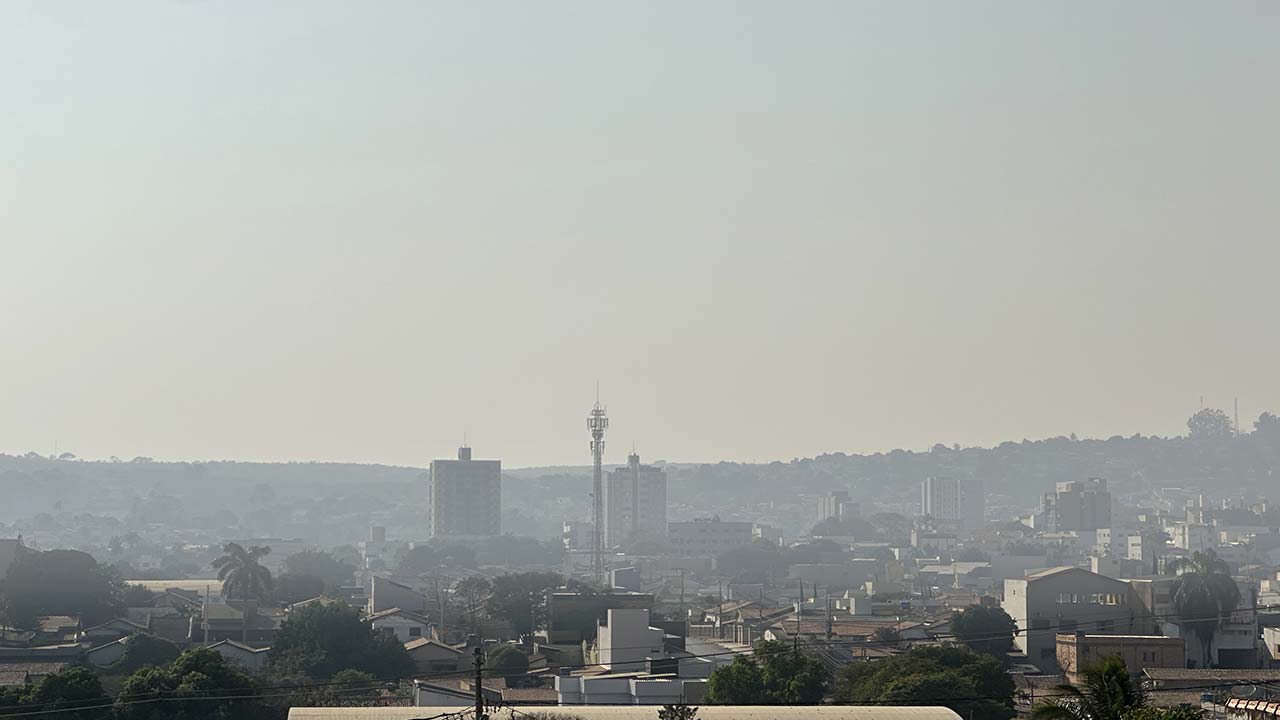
[{"xmin": 707, "ymin": 641, "xmax": 827, "ymax": 705}]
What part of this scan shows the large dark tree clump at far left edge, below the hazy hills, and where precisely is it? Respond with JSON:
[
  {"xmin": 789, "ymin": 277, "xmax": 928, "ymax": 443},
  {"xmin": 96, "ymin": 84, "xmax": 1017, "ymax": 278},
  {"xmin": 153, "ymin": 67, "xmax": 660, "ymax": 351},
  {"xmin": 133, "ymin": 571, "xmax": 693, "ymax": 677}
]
[{"xmin": 0, "ymin": 550, "xmax": 123, "ymax": 628}]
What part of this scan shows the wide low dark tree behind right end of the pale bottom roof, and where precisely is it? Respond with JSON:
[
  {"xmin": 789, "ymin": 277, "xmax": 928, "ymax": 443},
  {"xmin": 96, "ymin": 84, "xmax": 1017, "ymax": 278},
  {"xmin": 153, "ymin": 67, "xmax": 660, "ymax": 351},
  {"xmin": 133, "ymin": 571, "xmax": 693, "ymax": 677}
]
[{"xmin": 833, "ymin": 646, "xmax": 1014, "ymax": 720}]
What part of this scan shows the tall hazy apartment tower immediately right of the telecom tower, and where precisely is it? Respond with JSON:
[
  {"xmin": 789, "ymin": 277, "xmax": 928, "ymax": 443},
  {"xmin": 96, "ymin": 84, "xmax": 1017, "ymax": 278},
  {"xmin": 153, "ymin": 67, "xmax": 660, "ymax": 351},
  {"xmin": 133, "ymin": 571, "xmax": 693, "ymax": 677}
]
[{"xmin": 604, "ymin": 452, "xmax": 667, "ymax": 547}]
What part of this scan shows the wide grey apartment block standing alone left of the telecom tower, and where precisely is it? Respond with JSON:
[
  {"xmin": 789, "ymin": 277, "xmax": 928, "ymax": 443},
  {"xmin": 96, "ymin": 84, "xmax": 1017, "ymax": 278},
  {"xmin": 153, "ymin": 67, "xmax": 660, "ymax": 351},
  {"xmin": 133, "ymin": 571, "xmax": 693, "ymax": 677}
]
[{"xmin": 431, "ymin": 447, "xmax": 502, "ymax": 538}]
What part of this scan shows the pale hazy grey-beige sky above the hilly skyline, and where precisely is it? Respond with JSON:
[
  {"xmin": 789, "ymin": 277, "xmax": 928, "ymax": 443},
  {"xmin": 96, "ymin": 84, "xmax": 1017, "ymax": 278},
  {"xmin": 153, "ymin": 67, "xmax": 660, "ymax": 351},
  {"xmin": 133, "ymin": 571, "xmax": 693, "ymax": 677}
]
[{"xmin": 0, "ymin": 0, "xmax": 1280, "ymax": 466}]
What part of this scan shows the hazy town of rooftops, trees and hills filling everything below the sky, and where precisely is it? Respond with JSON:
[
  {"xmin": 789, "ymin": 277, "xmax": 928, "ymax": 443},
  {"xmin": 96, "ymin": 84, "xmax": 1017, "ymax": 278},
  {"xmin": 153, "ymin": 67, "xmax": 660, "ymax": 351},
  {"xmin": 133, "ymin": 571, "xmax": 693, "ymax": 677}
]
[{"xmin": 0, "ymin": 405, "xmax": 1280, "ymax": 720}]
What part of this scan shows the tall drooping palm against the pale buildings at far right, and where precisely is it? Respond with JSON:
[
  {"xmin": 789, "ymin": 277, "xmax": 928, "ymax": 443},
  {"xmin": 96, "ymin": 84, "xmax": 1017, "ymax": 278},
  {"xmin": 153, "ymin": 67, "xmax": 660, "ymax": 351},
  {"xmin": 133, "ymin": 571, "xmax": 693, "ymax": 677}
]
[{"xmin": 1165, "ymin": 550, "xmax": 1240, "ymax": 667}]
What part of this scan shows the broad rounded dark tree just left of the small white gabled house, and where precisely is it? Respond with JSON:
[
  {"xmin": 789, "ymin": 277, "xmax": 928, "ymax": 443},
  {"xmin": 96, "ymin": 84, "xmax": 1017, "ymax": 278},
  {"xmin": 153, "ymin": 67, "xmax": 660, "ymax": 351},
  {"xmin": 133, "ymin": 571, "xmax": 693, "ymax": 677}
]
[{"xmin": 270, "ymin": 603, "xmax": 413, "ymax": 680}]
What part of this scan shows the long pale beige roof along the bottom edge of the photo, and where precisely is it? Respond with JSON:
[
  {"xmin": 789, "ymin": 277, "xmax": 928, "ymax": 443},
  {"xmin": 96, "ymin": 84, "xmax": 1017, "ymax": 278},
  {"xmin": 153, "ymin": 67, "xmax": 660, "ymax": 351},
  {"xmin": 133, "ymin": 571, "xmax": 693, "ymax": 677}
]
[{"xmin": 289, "ymin": 705, "xmax": 960, "ymax": 720}]
